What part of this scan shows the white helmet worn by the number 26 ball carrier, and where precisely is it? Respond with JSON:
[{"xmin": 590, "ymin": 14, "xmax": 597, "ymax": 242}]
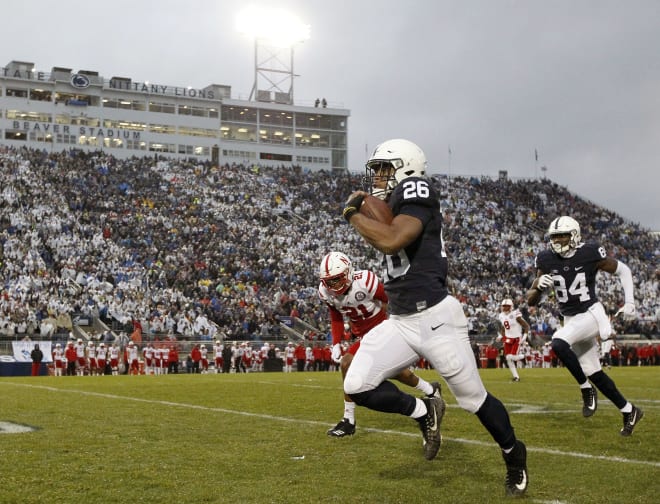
[{"xmin": 364, "ymin": 138, "xmax": 426, "ymax": 200}]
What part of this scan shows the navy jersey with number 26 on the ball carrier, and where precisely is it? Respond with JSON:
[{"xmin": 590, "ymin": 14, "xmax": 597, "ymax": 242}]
[{"xmin": 383, "ymin": 177, "xmax": 447, "ymax": 315}]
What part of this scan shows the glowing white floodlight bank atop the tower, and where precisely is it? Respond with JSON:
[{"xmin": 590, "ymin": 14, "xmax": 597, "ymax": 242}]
[{"xmin": 236, "ymin": 6, "xmax": 309, "ymax": 47}]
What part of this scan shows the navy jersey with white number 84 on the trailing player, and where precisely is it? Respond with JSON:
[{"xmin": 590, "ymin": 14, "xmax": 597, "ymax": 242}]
[{"xmin": 536, "ymin": 243, "xmax": 607, "ymax": 315}]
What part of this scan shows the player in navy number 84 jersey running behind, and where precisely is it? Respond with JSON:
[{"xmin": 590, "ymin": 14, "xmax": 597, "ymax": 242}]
[{"xmin": 527, "ymin": 216, "xmax": 644, "ymax": 436}]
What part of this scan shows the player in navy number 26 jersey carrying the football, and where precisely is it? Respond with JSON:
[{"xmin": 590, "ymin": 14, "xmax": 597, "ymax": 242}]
[{"xmin": 343, "ymin": 139, "xmax": 528, "ymax": 496}]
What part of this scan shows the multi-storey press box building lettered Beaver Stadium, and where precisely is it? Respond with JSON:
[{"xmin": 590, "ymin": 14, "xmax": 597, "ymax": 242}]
[{"xmin": 0, "ymin": 61, "xmax": 350, "ymax": 171}]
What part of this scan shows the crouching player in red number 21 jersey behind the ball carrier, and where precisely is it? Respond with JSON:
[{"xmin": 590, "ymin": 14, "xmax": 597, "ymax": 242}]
[{"xmin": 319, "ymin": 252, "xmax": 444, "ymax": 438}]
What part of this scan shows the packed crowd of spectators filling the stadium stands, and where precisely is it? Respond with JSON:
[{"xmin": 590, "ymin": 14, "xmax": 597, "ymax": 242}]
[{"xmin": 0, "ymin": 147, "xmax": 660, "ymax": 350}]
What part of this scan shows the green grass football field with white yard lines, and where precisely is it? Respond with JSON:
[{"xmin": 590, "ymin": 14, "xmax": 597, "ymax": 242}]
[{"xmin": 0, "ymin": 367, "xmax": 660, "ymax": 504}]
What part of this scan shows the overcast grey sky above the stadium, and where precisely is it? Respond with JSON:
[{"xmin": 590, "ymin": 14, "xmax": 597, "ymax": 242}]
[{"xmin": 5, "ymin": 0, "xmax": 660, "ymax": 230}]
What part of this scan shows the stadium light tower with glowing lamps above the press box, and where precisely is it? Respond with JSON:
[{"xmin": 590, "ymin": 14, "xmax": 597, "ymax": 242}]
[{"xmin": 236, "ymin": 7, "xmax": 310, "ymax": 105}]
